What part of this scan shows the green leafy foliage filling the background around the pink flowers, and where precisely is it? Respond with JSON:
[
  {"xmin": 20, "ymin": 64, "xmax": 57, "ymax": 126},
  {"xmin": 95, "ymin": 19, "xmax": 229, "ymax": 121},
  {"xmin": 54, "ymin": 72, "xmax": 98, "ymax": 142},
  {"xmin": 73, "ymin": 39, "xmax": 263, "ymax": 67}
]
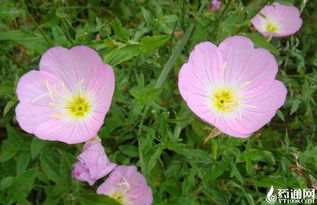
[{"xmin": 0, "ymin": 0, "xmax": 317, "ymax": 205}]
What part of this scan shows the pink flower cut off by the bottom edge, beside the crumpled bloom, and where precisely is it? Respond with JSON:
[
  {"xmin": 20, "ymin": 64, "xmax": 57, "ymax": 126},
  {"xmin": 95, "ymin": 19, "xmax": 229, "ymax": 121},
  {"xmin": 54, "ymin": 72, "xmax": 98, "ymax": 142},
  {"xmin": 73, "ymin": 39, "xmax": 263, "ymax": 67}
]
[{"xmin": 97, "ymin": 166, "xmax": 153, "ymax": 205}]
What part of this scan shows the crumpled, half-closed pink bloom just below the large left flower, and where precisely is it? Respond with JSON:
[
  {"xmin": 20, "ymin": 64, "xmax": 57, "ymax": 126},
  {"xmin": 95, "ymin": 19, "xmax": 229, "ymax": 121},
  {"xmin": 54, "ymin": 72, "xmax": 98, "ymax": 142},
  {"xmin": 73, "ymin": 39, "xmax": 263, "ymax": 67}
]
[{"xmin": 72, "ymin": 137, "xmax": 117, "ymax": 186}]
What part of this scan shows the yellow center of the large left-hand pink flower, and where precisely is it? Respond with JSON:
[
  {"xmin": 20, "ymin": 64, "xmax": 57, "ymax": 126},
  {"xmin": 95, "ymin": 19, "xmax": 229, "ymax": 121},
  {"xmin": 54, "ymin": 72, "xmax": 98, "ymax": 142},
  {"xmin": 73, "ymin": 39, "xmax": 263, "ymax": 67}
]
[{"xmin": 65, "ymin": 95, "xmax": 92, "ymax": 119}]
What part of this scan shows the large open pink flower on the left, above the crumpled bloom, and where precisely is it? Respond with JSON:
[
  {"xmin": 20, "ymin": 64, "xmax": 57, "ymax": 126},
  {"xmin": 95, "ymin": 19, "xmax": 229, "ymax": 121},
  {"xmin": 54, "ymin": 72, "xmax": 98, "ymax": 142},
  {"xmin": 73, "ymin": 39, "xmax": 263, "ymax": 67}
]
[{"xmin": 16, "ymin": 46, "xmax": 115, "ymax": 144}]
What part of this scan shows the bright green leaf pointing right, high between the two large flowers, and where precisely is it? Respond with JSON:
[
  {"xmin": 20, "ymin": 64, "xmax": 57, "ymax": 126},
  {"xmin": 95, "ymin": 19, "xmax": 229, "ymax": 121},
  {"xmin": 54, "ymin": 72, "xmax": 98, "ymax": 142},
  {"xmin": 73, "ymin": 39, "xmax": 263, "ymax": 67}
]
[{"xmin": 140, "ymin": 35, "xmax": 170, "ymax": 53}]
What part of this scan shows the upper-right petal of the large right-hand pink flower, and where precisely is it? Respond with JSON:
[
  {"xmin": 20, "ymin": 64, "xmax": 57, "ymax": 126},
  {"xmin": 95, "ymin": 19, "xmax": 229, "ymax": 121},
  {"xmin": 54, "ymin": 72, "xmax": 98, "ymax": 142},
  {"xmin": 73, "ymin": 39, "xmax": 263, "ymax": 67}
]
[{"xmin": 219, "ymin": 36, "xmax": 278, "ymax": 93}]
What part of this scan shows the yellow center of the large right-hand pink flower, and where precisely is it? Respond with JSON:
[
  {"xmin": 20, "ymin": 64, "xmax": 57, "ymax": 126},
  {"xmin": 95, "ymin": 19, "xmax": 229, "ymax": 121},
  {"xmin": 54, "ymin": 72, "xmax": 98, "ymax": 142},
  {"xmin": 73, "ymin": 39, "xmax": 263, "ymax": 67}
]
[{"xmin": 211, "ymin": 87, "xmax": 240, "ymax": 113}]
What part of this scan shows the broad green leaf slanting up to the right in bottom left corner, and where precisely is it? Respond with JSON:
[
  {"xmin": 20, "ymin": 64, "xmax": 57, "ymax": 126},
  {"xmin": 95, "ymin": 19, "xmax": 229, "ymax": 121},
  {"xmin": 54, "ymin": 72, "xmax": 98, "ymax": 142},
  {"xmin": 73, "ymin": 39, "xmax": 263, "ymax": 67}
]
[{"xmin": 8, "ymin": 169, "xmax": 37, "ymax": 204}]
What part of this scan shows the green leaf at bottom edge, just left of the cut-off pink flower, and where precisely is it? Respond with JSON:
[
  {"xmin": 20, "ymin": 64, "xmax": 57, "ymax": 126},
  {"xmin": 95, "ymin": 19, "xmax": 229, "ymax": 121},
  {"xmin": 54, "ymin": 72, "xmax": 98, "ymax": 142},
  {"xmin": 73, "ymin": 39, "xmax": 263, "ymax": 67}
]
[{"xmin": 79, "ymin": 193, "xmax": 120, "ymax": 205}]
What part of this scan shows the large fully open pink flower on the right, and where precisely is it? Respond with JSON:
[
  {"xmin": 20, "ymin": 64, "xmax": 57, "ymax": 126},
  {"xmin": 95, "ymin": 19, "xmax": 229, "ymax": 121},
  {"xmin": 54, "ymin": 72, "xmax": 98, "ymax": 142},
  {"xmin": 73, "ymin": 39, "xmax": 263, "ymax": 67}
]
[{"xmin": 178, "ymin": 36, "xmax": 287, "ymax": 137}]
